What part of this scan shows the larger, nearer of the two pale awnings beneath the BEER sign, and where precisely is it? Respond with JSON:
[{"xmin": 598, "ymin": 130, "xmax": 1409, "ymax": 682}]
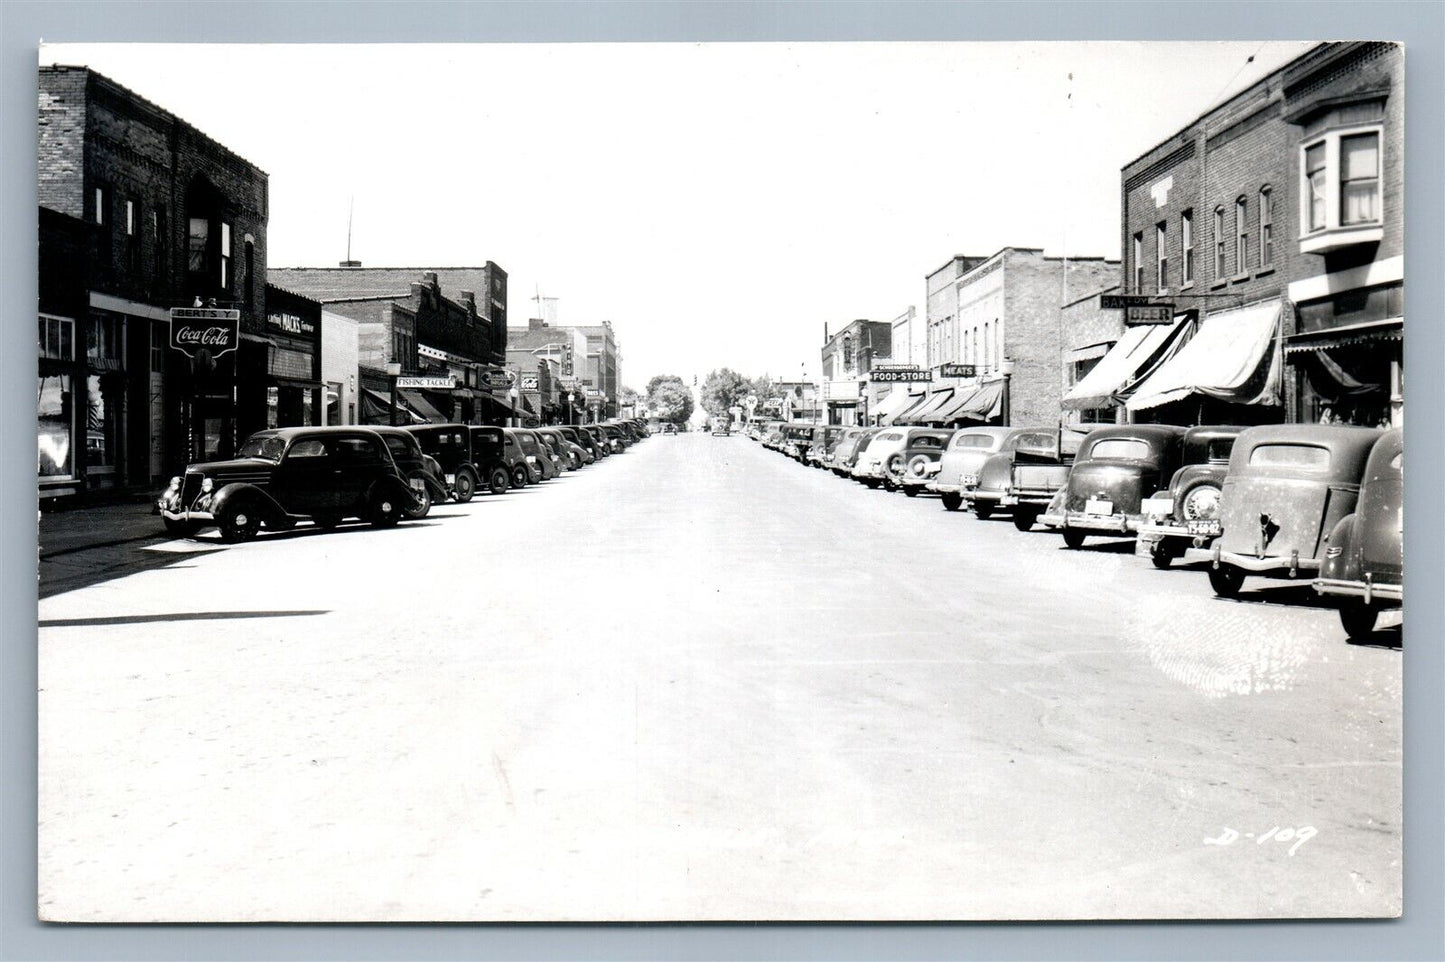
[{"xmin": 1126, "ymin": 300, "xmax": 1280, "ymax": 410}]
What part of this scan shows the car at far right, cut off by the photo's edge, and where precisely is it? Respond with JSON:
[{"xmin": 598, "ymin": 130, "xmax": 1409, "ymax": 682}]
[{"xmin": 1315, "ymin": 429, "xmax": 1405, "ymax": 638}]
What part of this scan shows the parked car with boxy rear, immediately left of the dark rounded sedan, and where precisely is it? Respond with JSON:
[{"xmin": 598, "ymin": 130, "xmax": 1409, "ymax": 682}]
[{"xmin": 965, "ymin": 428, "xmax": 1082, "ymax": 520}]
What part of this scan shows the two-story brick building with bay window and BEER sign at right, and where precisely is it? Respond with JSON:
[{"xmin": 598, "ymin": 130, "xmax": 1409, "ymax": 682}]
[{"xmin": 1086, "ymin": 42, "xmax": 1405, "ymax": 425}]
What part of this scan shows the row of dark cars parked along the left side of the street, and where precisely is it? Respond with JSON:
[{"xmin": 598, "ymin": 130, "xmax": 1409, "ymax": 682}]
[{"xmin": 156, "ymin": 420, "xmax": 647, "ymax": 543}]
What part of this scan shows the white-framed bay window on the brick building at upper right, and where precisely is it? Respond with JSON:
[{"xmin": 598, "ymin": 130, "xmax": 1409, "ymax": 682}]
[{"xmin": 1299, "ymin": 100, "xmax": 1384, "ymax": 254}]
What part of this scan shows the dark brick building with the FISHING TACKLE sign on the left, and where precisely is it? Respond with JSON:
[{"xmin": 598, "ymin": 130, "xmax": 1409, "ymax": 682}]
[{"xmin": 270, "ymin": 260, "xmax": 512, "ymax": 423}]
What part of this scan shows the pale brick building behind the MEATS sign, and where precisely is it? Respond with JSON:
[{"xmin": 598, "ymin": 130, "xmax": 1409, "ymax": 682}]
[{"xmin": 892, "ymin": 247, "xmax": 1118, "ymax": 425}]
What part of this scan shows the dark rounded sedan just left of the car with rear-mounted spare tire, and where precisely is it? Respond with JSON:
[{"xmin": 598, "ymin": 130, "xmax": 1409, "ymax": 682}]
[{"xmin": 1038, "ymin": 425, "xmax": 1185, "ymax": 547}]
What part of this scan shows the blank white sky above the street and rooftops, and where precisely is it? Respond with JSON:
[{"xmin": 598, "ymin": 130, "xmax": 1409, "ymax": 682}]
[{"xmin": 40, "ymin": 42, "xmax": 1308, "ymax": 389}]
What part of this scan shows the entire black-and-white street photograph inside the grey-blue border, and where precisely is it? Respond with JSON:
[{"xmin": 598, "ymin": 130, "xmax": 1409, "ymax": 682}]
[{"xmin": 36, "ymin": 35, "xmax": 1410, "ymax": 923}]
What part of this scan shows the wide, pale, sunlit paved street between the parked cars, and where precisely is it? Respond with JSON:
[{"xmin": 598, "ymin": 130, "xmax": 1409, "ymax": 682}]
[{"xmin": 39, "ymin": 435, "xmax": 1402, "ymax": 920}]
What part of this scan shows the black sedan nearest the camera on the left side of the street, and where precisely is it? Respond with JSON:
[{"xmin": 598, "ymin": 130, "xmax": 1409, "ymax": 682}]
[{"xmin": 156, "ymin": 428, "xmax": 425, "ymax": 543}]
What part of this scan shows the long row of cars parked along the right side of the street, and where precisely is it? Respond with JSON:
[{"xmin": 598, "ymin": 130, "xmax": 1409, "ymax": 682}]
[{"xmin": 749, "ymin": 422, "xmax": 1405, "ymax": 637}]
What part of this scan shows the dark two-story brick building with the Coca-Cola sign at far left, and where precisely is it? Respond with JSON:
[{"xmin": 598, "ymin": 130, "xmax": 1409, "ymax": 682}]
[{"xmin": 36, "ymin": 66, "xmax": 276, "ymax": 495}]
